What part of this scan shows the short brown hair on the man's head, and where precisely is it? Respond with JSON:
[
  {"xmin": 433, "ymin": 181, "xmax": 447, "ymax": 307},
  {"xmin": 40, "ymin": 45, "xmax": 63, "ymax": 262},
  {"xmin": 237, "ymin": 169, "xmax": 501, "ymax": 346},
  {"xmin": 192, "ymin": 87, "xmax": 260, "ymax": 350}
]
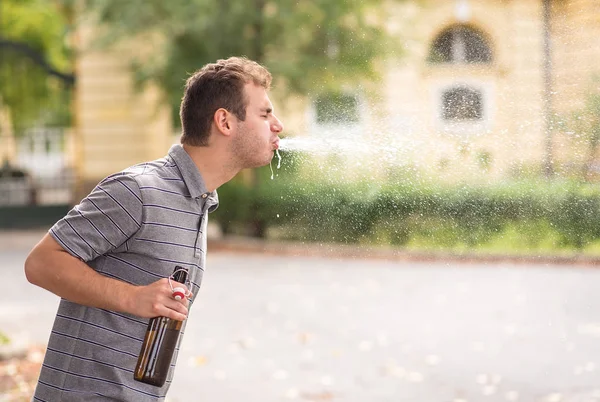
[{"xmin": 179, "ymin": 57, "xmax": 271, "ymax": 146}]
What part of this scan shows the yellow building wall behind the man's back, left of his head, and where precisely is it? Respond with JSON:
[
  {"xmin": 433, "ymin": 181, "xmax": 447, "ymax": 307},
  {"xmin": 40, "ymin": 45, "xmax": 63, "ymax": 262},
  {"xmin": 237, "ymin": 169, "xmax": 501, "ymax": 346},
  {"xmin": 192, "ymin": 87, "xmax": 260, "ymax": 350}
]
[{"xmin": 75, "ymin": 27, "xmax": 173, "ymax": 197}]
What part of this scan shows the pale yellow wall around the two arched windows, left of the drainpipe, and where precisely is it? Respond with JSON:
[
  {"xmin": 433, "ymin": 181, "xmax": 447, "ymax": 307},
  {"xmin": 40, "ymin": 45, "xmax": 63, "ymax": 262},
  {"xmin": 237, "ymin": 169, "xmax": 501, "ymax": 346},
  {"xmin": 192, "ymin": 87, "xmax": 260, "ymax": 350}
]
[{"xmin": 382, "ymin": 0, "xmax": 544, "ymax": 177}]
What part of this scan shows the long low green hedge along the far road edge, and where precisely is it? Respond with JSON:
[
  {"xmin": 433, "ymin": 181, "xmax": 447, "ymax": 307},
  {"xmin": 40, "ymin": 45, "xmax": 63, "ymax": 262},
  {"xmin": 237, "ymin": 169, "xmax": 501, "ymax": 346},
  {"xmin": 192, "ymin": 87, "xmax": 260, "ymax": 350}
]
[{"xmin": 211, "ymin": 173, "xmax": 600, "ymax": 251}]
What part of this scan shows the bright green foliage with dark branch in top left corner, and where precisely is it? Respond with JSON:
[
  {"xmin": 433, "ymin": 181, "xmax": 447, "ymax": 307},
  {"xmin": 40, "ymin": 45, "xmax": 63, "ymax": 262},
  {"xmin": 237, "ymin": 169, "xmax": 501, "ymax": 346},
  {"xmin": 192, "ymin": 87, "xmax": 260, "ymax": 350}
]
[{"xmin": 0, "ymin": 0, "xmax": 70, "ymax": 132}]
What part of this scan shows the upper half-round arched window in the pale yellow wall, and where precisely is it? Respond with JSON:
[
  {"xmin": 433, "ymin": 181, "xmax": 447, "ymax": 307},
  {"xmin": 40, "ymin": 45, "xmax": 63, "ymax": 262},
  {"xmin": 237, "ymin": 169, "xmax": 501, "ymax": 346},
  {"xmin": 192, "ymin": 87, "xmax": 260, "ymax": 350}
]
[{"xmin": 427, "ymin": 25, "xmax": 492, "ymax": 64}]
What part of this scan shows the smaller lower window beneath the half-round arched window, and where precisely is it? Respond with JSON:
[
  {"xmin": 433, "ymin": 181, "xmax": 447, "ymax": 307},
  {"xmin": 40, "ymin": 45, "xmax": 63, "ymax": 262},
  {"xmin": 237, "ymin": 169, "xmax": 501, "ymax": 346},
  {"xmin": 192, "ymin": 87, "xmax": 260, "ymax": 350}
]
[{"xmin": 442, "ymin": 86, "xmax": 483, "ymax": 122}]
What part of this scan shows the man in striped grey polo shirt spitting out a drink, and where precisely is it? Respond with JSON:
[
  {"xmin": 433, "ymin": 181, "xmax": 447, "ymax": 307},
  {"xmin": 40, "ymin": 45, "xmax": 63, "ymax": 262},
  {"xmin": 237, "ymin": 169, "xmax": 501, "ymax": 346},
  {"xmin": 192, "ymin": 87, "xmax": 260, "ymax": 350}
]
[{"xmin": 25, "ymin": 57, "xmax": 283, "ymax": 402}]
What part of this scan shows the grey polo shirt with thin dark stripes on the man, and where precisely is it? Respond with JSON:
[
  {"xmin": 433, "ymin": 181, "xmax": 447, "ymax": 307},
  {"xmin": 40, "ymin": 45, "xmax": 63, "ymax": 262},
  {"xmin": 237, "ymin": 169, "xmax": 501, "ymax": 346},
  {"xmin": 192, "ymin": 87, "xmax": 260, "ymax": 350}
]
[{"xmin": 34, "ymin": 145, "xmax": 218, "ymax": 402}]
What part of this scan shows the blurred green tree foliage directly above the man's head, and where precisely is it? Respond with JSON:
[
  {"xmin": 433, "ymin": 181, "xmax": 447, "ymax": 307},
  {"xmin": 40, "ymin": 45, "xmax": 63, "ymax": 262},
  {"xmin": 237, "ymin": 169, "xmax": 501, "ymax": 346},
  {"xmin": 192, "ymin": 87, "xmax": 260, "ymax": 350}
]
[{"xmin": 79, "ymin": 0, "xmax": 399, "ymax": 121}]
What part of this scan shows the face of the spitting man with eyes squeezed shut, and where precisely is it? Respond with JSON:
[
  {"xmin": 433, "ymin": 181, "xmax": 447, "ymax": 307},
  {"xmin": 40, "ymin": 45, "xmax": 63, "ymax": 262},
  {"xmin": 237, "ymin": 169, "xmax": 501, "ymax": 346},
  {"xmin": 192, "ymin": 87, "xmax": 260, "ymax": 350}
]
[{"xmin": 231, "ymin": 83, "xmax": 283, "ymax": 168}]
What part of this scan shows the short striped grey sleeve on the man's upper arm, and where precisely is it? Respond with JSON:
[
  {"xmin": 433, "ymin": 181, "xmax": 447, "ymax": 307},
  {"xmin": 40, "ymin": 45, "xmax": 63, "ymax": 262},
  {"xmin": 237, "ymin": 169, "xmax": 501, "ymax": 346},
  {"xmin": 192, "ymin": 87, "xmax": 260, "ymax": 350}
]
[{"xmin": 50, "ymin": 173, "xmax": 143, "ymax": 261}]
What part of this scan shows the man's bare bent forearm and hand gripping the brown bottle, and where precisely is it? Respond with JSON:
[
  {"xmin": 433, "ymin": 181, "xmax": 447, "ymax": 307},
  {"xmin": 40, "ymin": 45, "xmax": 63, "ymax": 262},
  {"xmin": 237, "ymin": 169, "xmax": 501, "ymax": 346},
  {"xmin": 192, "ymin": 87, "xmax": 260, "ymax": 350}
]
[{"xmin": 25, "ymin": 234, "xmax": 188, "ymax": 321}]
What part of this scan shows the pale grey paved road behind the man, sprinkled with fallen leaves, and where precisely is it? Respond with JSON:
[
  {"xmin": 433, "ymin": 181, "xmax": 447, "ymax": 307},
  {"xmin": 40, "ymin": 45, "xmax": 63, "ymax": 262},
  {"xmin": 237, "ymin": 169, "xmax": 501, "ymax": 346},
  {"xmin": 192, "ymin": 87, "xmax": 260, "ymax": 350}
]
[{"xmin": 0, "ymin": 236, "xmax": 600, "ymax": 402}]
